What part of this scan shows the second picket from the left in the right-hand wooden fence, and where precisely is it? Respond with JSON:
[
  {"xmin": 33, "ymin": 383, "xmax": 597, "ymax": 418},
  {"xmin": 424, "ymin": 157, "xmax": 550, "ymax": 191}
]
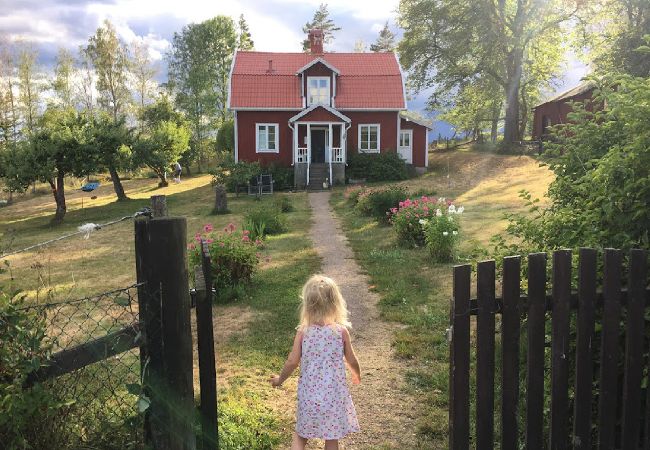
[{"xmin": 476, "ymin": 261, "xmax": 496, "ymax": 450}]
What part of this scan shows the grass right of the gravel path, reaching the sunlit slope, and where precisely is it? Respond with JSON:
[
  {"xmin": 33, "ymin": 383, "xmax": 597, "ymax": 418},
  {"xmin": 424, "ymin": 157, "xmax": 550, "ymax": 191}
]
[{"xmin": 332, "ymin": 151, "xmax": 551, "ymax": 442}]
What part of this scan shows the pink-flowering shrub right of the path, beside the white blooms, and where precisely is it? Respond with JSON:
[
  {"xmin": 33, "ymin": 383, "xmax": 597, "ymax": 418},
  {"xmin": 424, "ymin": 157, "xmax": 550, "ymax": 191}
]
[{"xmin": 390, "ymin": 196, "xmax": 447, "ymax": 247}]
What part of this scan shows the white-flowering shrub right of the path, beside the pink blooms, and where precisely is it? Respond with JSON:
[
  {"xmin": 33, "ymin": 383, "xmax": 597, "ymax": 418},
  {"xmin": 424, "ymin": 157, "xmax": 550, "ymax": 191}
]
[{"xmin": 420, "ymin": 204, "xmax": 463, "ymax": 262}]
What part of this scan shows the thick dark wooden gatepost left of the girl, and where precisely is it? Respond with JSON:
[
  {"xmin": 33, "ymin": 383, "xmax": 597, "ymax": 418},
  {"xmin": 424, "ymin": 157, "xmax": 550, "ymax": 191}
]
[{"xmin": 135, "ymin": 217, "xmax": 196, "ymax": 450}]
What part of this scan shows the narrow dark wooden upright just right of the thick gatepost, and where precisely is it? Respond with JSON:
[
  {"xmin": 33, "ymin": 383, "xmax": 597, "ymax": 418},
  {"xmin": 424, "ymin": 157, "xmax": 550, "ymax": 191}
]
[{"xmin": 195, "ymin": 241, "xmax": 219, "ymax": 450}]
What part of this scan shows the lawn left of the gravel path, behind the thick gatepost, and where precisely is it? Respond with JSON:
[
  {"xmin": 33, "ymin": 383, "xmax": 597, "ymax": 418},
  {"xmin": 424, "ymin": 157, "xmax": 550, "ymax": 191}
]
[{"xmin": 0, "ymin": 175, "xmax": 320, "ymax": 449}]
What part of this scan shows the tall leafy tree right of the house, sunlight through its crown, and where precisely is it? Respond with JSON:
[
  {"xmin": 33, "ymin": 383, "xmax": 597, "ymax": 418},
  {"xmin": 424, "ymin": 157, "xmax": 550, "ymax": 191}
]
[{"xmin": 398, "ymin": 0, "xmax": 576, "ymax": 145}]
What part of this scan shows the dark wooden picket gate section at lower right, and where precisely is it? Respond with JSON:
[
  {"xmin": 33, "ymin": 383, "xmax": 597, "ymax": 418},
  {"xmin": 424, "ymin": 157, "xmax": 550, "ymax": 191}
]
[{"xmin": 449, "ymin": 249, "xmax": 650, "ymax": 450}]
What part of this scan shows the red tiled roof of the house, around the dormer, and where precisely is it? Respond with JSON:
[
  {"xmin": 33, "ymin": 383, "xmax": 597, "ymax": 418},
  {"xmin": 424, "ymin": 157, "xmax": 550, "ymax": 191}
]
[{"xmin": 230, "ymin": 51, "xmax": 406, "ymax": 109}]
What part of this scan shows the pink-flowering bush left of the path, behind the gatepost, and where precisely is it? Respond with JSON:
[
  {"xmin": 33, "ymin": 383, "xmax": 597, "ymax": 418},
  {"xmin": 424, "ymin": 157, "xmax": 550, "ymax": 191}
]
[{"xmin": 188, "ymin": 224, "xmax": 262, "ymax": 300}]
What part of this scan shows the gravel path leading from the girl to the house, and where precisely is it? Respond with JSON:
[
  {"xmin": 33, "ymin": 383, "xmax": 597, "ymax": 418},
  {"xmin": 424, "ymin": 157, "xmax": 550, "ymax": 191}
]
[{"xmin": 302, "ymin": 192, "xmax": 417, "ymax": 450}]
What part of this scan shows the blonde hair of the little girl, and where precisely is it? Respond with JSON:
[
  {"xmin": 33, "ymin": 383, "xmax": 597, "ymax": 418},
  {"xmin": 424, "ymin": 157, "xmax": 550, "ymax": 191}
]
[{"xmin": 298, "ymin": 275, "xmax": 352, "ymax": 329}]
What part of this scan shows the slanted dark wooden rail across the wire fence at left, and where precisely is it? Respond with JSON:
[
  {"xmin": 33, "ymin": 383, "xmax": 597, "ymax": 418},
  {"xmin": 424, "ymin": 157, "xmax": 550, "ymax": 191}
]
[{"xmin": 26, "ymin": 324, "xmax": 140, "ymax": 386}]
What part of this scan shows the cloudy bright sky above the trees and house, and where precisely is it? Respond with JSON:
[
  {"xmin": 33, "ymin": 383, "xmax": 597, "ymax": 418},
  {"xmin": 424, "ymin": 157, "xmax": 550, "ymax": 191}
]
[{"xmin": 0, "ymin": 0, "xmax": 587, "ymax": 137}]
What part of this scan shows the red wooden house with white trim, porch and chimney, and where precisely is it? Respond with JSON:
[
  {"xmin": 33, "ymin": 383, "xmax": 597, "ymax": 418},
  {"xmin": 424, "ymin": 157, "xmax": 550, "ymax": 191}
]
[{"xmin": 228, "ymin": 30, "xmax": 430, "ymax": 188}]
